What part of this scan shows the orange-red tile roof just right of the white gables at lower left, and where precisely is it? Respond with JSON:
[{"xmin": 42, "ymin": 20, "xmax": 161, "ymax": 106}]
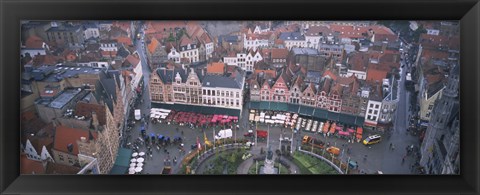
[{"xmin": 53, "ymin": 125, "xmax": 97, "ymax": 155}]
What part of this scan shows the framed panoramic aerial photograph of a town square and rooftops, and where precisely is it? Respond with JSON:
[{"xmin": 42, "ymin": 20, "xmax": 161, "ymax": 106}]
[{"xmin": 20, "ymin": 21, "xmax": 460, "ymax": 175}]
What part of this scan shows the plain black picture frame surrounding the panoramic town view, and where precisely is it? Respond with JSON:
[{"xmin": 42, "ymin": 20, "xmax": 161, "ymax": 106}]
[{"xmin": 0, "ymin": 0, "xmax": 480, "ymax": 194}]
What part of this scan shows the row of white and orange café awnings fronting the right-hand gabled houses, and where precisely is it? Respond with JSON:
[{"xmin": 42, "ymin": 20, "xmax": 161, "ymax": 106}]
[{"xmin": 249, "ymin": 102, "xmax": 364, "ymax": 142}]
